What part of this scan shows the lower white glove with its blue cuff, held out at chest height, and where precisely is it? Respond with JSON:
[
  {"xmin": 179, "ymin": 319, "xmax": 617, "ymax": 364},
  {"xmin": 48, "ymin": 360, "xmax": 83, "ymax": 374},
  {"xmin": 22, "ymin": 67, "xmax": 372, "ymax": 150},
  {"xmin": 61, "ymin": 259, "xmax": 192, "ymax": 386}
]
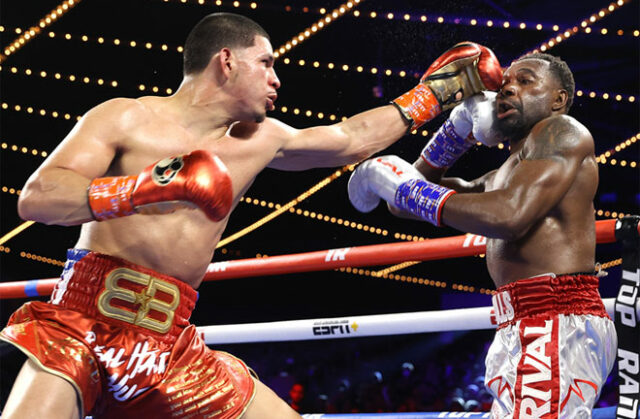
[{"xmin": 348, "ymin": 156, "xmax": 456, "ymax": 226}]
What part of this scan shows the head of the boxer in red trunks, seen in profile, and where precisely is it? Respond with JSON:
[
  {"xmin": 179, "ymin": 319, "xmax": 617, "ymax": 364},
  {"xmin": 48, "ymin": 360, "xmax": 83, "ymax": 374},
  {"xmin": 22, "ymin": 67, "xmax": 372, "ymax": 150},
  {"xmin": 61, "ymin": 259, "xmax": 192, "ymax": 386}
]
[{"xmin": 183, "ymin": 13, "xmax": 280, "ymax": 122}]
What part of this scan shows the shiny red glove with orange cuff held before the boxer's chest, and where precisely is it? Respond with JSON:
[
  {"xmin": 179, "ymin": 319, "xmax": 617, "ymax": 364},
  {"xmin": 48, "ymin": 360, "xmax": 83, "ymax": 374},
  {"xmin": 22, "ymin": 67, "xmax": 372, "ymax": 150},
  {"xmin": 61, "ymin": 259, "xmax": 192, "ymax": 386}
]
[{"xmin": 88, "ymin": 150, "xmax": 233, "ymax": 221}]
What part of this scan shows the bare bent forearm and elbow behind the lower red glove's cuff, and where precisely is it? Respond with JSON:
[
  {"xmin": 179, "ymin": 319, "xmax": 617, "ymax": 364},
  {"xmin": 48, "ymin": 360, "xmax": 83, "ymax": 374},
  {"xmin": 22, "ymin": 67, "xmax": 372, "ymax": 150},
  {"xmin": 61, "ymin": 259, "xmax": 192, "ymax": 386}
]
[{"xmin": 18, "ymin": 168, "xmax": 93, "ymax": 225}]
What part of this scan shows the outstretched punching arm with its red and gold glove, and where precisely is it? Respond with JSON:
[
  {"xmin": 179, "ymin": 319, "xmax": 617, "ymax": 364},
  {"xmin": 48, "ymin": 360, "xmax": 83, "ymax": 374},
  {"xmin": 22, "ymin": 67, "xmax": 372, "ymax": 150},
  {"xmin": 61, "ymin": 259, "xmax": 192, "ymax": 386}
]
[{"xmin": 269, "ymin": 42, "xmax": 502, "ymax": 170}]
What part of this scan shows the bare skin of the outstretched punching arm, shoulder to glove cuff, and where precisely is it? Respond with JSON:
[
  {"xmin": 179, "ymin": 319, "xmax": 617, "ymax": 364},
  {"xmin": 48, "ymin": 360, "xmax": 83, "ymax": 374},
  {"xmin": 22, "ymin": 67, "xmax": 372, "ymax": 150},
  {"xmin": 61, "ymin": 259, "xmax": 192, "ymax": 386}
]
[{"xmin": 267, "ymin": 105, "xmax": 408, "ymax": 170}]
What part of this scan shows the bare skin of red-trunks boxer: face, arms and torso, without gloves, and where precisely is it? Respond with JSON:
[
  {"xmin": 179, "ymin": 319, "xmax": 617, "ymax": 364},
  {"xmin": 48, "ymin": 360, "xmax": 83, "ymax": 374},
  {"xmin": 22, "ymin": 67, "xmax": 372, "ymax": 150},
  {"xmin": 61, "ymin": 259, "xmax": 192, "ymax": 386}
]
[{"xmin": 18, "ymin": 37, "xmax": 406, "ymax": 288}]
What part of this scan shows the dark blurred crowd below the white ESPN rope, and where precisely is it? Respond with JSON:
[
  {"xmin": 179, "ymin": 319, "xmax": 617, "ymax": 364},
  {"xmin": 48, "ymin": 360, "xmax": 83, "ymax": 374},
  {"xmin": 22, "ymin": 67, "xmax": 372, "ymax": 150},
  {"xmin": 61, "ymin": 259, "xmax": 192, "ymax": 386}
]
[{"xmin": 220, "ymin": 331, "xmax": 617, "ymax": 413}]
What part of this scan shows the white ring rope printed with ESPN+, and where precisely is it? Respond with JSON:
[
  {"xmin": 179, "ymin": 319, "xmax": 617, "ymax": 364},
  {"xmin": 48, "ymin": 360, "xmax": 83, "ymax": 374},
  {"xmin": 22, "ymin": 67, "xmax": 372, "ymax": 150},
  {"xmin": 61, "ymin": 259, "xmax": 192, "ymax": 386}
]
[{"xmin": 198, "ymin": 298, "xmax": 615, "ymax": 345}]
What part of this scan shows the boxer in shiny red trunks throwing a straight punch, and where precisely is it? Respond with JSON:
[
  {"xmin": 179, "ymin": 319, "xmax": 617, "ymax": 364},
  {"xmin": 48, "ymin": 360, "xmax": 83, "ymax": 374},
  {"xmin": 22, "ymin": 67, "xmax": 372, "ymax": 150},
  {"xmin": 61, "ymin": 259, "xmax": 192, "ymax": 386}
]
[{"xmin": 0, "ymin": 13, "xmax": 502, "ymax": 419}]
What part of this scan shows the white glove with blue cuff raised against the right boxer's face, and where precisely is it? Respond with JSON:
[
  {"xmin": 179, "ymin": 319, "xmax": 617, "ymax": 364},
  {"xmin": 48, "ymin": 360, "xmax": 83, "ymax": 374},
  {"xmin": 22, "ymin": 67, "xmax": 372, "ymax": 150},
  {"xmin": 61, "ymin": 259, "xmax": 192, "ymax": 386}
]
[{"xmin": 420, "ymin": 92, "xmax": 502, "ymax": 168}]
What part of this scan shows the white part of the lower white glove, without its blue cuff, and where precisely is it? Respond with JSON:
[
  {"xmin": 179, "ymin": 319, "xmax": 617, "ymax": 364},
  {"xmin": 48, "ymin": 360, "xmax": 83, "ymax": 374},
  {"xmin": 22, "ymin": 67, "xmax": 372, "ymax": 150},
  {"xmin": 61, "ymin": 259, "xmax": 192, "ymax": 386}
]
[{"xmin": 348, "ymin": 155, "xmax": 424, "ymax": 212}]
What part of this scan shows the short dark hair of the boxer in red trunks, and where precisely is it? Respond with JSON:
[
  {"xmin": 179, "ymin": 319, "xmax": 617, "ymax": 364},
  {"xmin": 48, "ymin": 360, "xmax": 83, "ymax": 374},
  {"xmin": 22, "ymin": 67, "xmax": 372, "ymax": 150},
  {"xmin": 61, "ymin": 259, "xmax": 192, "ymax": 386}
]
[{"xmin": 182, "ymin": 13, "xmax": 269, "ymax": 75}]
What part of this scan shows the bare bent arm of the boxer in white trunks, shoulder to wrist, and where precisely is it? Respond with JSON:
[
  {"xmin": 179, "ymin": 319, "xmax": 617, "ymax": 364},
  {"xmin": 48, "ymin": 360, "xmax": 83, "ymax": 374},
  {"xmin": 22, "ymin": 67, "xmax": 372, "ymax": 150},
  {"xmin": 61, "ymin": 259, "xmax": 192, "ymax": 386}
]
[{"xmin": 442, "ymin": 116, "xmax": 593, "ymax": 240}]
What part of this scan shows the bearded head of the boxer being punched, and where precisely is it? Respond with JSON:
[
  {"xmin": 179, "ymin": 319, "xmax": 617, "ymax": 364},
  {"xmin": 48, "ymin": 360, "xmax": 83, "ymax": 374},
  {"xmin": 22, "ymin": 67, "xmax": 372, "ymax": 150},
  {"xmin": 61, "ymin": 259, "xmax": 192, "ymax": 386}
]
[{"xmin": 496, "ymin": 53, "xmax": 575, "ymax": 139}]
